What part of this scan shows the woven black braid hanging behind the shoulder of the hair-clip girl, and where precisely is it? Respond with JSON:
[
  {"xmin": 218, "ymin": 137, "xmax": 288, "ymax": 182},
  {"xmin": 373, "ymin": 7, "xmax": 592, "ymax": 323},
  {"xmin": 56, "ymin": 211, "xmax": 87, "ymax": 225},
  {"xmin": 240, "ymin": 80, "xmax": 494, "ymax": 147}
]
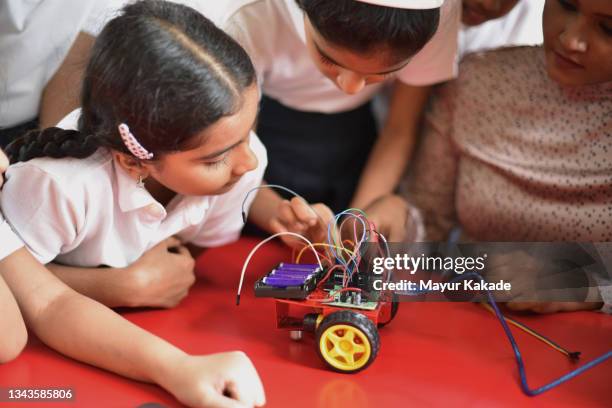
[{"xmin": 6, "ymin": 127, "xmax": 101, "ymax": 163}]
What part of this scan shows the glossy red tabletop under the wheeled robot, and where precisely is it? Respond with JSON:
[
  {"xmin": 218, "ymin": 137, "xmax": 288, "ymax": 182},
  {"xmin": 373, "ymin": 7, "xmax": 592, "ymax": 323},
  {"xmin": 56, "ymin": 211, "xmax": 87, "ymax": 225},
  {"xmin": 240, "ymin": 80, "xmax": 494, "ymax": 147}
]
[{"xmin": 0, "ymin": 238, "xmax": 612, "ymax": 408}]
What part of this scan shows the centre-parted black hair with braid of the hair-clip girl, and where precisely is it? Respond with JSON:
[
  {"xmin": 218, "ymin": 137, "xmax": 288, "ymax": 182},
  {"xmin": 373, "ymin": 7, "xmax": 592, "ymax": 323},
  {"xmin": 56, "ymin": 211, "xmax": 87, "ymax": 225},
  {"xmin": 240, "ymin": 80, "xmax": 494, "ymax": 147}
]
[{"xmin": 0, "ymin": 0, "xmax": 256, "ymax": 163}]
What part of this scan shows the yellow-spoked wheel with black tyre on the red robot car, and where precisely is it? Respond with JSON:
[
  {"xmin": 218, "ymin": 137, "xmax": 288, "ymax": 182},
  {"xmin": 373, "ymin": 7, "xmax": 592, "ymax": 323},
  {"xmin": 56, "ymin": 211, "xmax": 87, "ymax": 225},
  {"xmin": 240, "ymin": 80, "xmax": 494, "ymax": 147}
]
[{"xmin": 317, "ymin": 310, "xmax": 380, "ymax": 373}]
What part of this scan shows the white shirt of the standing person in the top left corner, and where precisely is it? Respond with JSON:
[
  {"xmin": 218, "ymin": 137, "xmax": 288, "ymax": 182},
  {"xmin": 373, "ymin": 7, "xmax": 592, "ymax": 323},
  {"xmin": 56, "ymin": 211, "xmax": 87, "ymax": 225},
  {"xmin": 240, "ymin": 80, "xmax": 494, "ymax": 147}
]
[{"xmin": 0, "ymin": 0, "xmax": 121, "ymax": 128}]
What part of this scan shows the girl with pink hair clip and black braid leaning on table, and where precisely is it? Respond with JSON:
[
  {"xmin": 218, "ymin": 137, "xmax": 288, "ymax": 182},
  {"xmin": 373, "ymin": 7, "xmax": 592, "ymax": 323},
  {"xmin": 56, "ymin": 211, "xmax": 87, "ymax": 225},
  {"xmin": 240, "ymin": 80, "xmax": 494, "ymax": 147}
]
[{"xmin": 2, "ymin": 1, "xmax": 331, "ymax": 306}]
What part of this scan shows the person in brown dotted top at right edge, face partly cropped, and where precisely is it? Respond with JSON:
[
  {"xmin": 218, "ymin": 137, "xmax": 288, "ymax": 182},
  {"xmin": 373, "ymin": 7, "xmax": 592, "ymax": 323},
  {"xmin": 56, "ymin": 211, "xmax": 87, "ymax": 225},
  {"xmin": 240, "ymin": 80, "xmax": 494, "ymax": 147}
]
[{"xmin": 407, "ymin": 0, "xmax": 612, "ymax": 313}]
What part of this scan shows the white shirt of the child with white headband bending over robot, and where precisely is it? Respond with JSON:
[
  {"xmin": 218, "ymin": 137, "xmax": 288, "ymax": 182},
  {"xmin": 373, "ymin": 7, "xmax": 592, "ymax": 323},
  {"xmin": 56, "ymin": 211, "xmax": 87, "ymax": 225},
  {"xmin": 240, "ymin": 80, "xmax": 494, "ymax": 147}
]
[{"xmin": 178, "ymin": 0, "xmax": 461, "ymax": 113}]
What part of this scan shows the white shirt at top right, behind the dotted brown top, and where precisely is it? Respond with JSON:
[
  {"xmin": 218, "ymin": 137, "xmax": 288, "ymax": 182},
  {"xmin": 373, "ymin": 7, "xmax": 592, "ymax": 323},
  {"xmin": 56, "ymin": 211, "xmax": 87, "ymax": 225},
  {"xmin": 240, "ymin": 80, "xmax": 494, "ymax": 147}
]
[{"xmin": 459, "ymin": 0, "xmax": 545, "ymax": 58}]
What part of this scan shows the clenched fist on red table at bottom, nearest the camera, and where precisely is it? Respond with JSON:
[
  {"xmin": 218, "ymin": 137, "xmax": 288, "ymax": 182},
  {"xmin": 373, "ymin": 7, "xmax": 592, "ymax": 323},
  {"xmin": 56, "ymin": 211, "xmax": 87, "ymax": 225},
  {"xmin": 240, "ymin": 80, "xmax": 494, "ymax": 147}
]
[{"xmin": 160, "ymin": 351, "xmax": 266, "ymax": 408}]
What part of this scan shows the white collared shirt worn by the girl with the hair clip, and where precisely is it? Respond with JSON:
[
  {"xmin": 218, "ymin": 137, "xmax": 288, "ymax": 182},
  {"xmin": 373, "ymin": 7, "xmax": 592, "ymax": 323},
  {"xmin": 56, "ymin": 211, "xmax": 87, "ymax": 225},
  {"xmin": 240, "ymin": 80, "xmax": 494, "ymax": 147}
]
[{"xmin": 0, "ymin": 110, "xmax": 267, "ymax": 268}]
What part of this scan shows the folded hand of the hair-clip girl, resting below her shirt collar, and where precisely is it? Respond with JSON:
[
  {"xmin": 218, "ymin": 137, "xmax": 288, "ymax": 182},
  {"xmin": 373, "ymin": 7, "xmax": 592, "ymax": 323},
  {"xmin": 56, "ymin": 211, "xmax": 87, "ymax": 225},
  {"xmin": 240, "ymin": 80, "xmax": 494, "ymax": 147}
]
[{"xmin": 125, "ymin": 237, "xmax": 195, "ymax": 308}]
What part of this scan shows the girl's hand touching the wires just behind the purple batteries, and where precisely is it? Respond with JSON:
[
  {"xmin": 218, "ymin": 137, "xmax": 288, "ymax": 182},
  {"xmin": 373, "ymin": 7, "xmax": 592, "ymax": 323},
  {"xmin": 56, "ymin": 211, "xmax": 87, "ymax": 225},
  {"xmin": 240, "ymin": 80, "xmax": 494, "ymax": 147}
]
[{"xmin": 270, "ymin": 197, "xmax": 334, "ymax": 248}]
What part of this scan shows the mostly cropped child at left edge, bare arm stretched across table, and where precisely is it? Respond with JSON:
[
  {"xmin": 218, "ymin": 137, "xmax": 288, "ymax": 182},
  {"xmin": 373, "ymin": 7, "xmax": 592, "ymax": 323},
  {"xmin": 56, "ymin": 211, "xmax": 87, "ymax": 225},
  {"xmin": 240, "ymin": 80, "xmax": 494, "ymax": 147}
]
[{"xmin": 0, "ymin": 150, "xmax": 265, "ymax": 407}]
